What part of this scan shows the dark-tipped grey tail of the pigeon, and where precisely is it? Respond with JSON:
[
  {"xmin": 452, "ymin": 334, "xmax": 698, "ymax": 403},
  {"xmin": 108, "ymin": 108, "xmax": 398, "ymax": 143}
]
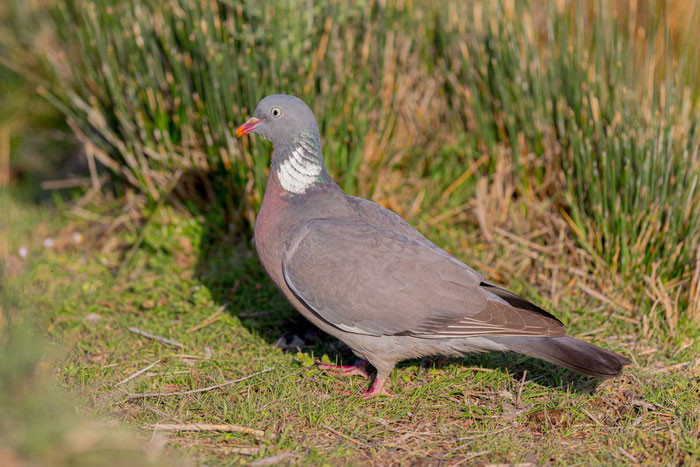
[{"xmin": 489, "ymin": 336, "xmax": 630, "ymax": 378}]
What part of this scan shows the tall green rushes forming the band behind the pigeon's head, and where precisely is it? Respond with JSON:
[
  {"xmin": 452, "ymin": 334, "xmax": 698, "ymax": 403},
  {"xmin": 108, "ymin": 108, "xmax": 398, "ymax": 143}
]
[{"xmin": 12, "ymin": 0, "xmax": 700, "ymax": 326}]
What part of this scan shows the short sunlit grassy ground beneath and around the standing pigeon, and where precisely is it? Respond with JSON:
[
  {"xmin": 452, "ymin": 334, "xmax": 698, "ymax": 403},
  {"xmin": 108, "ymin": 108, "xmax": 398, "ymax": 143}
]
[{"xmin": 5, "ymin": 192, "xmax": 700, "ymax": 465}]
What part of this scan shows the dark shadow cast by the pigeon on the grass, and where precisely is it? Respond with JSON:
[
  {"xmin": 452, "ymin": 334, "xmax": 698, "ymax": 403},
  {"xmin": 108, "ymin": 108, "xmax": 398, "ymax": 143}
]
[{"xmin": 195, "ymin": 211, "xmax": 599, "ymax": 393}]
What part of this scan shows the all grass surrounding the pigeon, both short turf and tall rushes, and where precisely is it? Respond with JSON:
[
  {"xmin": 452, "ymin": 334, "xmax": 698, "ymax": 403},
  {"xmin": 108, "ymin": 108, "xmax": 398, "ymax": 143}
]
[{"xmin": 0, "ymin": 0, "xmax": 700, "ymax": 465}]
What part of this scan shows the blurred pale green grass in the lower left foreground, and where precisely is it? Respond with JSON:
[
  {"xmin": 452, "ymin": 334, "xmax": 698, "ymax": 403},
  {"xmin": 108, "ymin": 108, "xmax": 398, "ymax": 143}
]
[{"xmin": 0, "ymin": 197, "xmax": 170, "ymax": 465}]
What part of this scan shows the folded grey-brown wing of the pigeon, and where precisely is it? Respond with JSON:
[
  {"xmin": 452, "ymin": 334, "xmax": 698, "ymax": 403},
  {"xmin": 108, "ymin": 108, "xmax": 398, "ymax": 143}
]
[{"xmin": 282, "ymin": 219, "xmax": 565, "ymax": 338}]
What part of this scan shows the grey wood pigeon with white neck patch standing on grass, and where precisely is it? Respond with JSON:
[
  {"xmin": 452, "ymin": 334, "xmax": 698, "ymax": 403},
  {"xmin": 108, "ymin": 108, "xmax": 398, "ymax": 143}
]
[{"xmin": 236, "ymin": 94, "xmax": 630, "ymax": 399}]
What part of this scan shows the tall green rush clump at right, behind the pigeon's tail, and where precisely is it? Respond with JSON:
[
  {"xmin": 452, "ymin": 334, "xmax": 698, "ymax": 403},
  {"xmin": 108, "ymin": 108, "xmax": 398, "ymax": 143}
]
[{"xmin": 436, "ymin": 2, "xmax": 700, "ymax": 288}]
